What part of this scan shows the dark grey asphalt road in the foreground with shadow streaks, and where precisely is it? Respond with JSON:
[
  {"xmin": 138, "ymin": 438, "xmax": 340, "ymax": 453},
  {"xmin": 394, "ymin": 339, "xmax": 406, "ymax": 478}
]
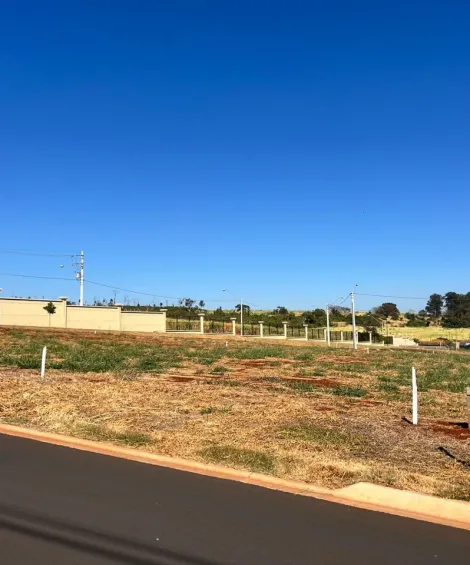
[{"xmin": 0, "ymin": 435, "xmax": 470, "ymax": 565}]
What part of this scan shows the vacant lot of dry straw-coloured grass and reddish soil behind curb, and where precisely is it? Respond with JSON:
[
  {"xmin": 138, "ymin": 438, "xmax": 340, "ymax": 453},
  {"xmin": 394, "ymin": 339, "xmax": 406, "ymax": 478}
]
[{"xmin": 0, "ymin": 329, "xmax": 470, "ymax": 500}]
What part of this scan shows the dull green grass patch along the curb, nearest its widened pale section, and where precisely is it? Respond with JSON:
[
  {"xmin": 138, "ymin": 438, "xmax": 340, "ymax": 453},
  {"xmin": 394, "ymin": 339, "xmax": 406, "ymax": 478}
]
[{"xmin": 199, "ymin": 445, "xmax": 276, "ymax": 474}]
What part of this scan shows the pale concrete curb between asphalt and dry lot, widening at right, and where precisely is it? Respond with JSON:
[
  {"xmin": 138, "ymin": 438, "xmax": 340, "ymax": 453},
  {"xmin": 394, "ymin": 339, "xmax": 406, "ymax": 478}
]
[{"xmin": 0, "ymin": 424, "xmax": 470, "ymax": 530}]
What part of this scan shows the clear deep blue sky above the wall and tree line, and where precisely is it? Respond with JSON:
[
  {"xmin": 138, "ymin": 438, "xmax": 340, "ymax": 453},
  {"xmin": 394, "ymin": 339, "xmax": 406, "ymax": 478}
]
[{"xmin": 0, "ymin": 0, "xmax": 470, "ymax": 309}]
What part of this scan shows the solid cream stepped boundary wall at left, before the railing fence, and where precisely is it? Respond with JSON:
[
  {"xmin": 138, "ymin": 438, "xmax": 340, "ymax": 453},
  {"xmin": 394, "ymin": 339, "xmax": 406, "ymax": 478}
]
[{"xmin": 0, "ymin": 298, "xmax": 166, "ymax": 332}]
